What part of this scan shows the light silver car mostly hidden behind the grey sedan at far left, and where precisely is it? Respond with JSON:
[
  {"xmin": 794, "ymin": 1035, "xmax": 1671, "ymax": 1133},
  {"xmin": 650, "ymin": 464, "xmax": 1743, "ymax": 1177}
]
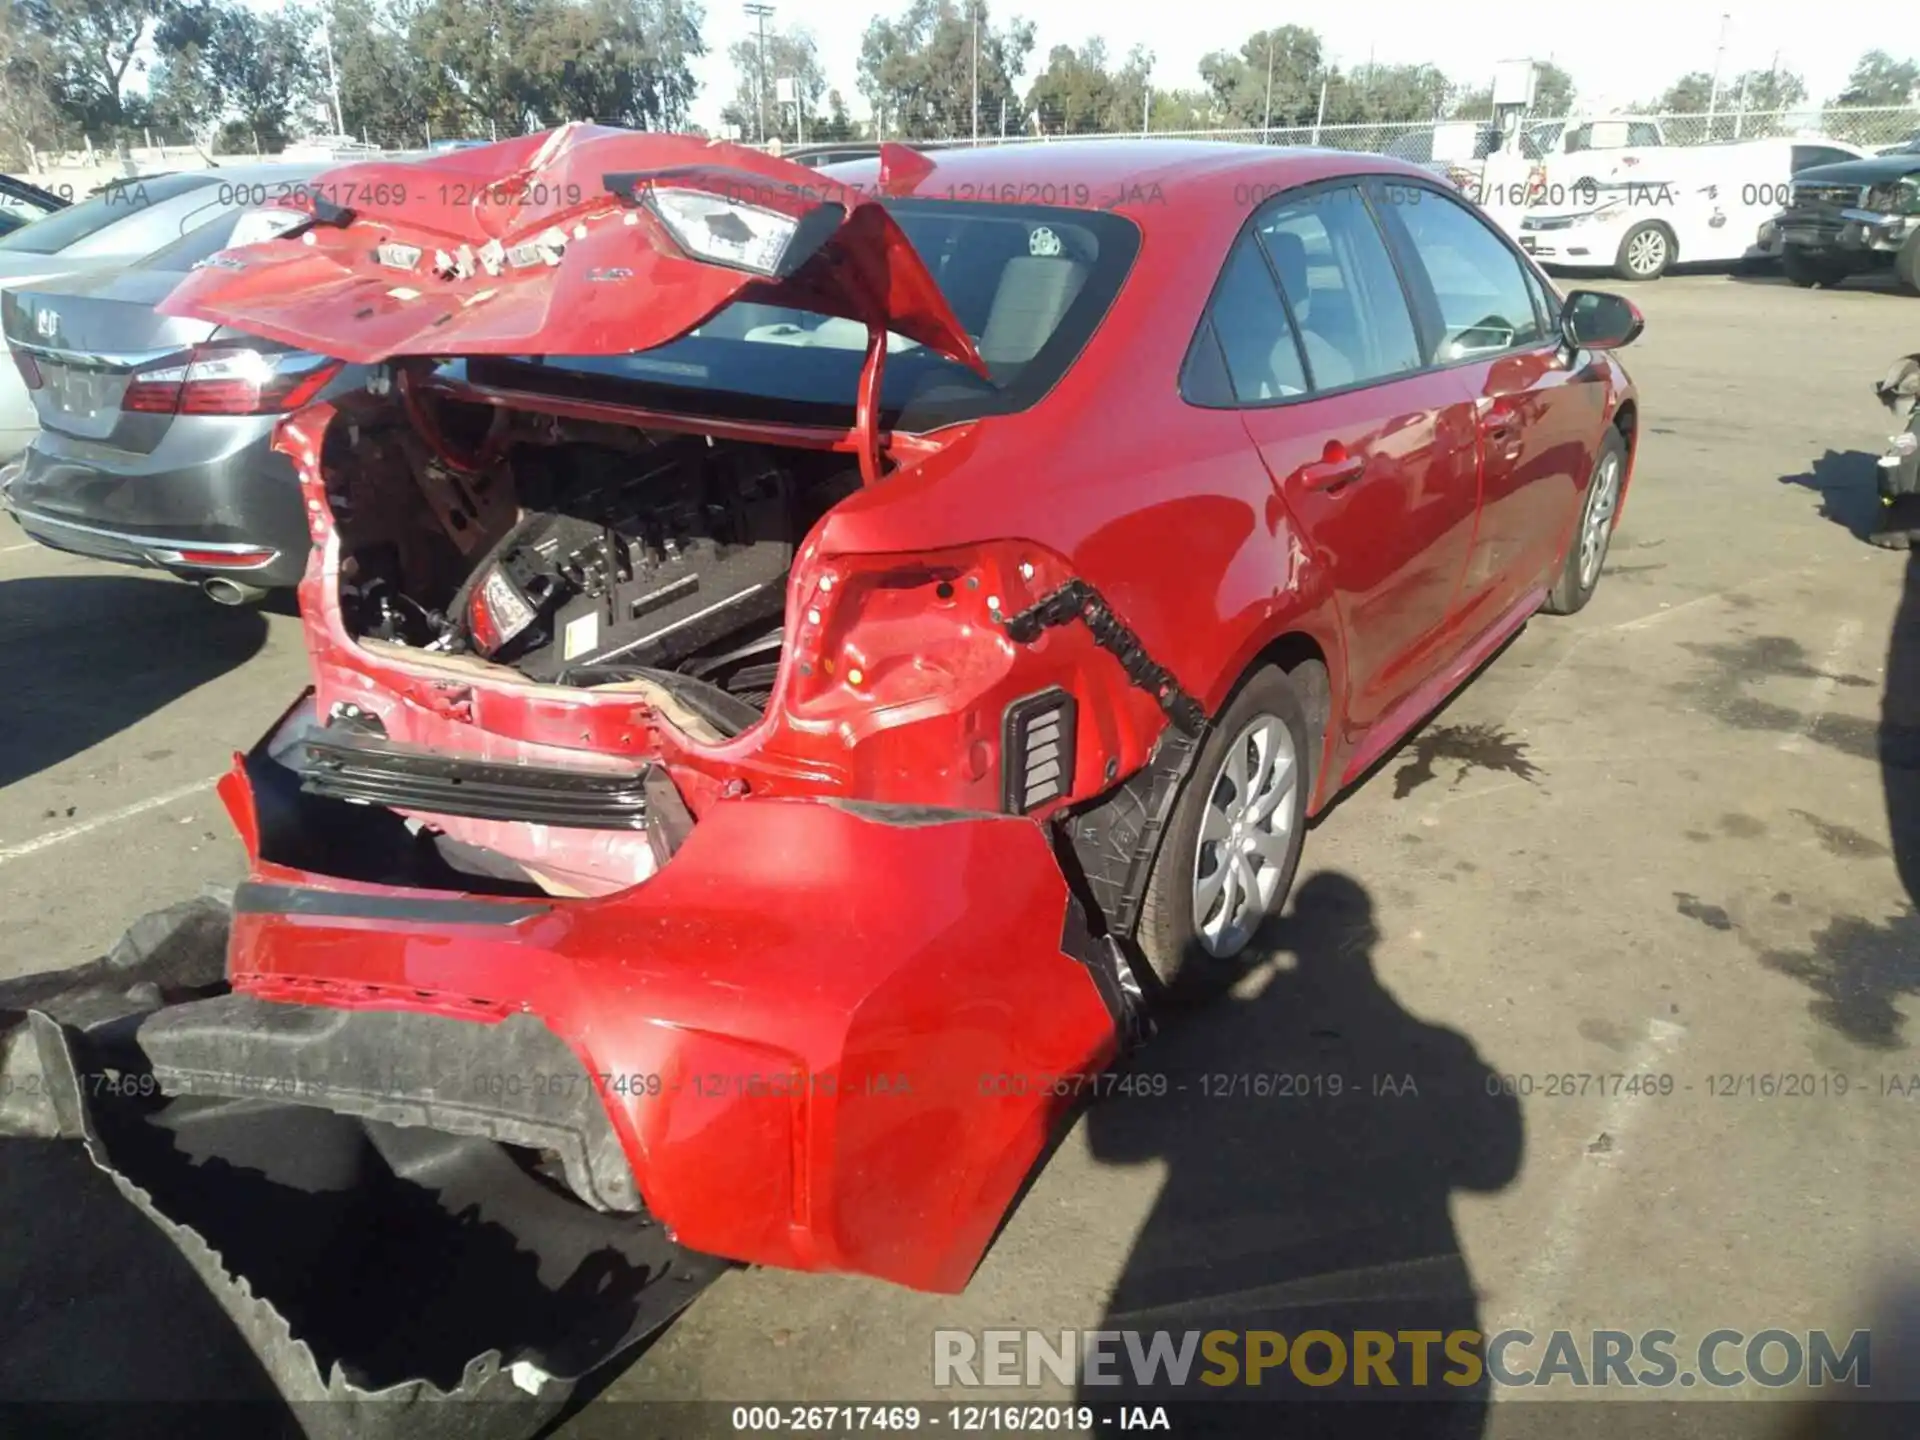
[{"xmin": 0, "ymin": 165, "xmax": 334, "ymax": 461}]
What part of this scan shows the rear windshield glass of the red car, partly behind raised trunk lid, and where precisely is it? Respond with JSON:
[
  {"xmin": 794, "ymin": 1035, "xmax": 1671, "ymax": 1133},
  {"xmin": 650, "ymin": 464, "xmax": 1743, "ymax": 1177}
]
[{"xmin": 467, "ymin": 200, "xmax": 1140, "ymax": 430}]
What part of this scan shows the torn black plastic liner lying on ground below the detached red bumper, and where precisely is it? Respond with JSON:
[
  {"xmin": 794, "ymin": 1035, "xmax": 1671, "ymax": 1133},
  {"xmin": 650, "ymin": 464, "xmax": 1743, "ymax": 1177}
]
[{"xmin": 0, "ymin": 906, "xmax": 728, "ymax": 1440}]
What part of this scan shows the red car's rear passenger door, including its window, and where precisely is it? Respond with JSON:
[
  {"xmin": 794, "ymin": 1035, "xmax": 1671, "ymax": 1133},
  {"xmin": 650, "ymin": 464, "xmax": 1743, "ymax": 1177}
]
[{"xmin": 1213, "ymin": 182, "xmax": 1478, "ymax": 739}]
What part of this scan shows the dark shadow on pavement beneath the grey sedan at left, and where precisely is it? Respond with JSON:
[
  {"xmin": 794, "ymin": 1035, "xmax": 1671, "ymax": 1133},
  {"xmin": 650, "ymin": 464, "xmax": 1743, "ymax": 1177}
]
[{"xmin": 0, "ymin": 574, "xmax": 267, "ymax": 785}]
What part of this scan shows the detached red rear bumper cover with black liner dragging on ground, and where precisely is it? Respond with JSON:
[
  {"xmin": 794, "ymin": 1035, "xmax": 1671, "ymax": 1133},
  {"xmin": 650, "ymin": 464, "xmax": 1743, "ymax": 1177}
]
[{"xmin": 0, "ymin": 706, "xmax": 1129, "ymax": 1436}]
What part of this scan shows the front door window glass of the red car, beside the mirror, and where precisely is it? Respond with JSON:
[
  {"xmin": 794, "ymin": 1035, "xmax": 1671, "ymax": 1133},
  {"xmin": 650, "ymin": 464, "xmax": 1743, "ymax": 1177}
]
[{"xmin": 1384, "ymin": 186, "xmax": 1542, "ymax": 365}]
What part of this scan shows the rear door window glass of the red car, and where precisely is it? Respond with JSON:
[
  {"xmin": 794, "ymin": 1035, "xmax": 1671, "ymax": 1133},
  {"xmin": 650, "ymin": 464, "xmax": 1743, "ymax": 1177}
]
[{"xmin": 1254, "ymin": 184, "xmax": 1421, "ymax": 390}]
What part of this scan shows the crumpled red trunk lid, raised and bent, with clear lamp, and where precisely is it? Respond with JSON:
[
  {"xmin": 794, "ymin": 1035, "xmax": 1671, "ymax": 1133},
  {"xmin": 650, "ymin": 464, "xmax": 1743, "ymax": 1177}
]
[{"xmin": 159, "ymin": 125, "xmax": 985, "ymax": 374}]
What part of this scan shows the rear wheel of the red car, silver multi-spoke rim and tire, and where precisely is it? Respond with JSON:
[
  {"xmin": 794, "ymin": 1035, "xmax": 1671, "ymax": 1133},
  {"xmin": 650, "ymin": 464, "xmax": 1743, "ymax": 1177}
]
[{"xmin": 1139, "ymin": 668, "xmax": 1319, "ymax": 1004}]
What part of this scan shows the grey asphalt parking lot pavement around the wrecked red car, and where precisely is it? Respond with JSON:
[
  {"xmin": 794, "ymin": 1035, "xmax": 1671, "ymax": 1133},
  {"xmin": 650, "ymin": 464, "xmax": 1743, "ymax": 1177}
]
[{"xmin": 0, "ymin": 275, "xmax": 1920, "ymax": 1436}]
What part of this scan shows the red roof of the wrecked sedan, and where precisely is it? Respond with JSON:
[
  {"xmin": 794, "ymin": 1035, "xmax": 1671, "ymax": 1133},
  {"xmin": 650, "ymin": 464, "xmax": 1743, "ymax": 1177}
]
[{"xmin": 822, "ymin": 138, "xmax": 1432, "ymax": 227}]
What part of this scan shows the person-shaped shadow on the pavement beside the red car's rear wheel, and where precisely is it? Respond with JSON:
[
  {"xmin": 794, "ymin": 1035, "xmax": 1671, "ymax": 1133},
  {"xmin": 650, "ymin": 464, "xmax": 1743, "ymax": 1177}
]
[{"xmin": 1079, "ymin": 872, "xmax": 1524, "ymax": 1440}]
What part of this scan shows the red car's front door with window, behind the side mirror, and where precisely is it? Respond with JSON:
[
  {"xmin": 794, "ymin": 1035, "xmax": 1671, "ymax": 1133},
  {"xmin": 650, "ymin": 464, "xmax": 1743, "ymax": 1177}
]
[{"xmin": 1373, "ymin": 182, "xmax": 1605, "ymax": 636}]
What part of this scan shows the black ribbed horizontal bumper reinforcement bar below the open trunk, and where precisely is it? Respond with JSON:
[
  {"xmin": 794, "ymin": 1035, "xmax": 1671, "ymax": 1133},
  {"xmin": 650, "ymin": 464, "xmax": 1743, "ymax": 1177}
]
[{"xmin": 301, "ymin": 732, "xmax": 653, "ymax": 829}]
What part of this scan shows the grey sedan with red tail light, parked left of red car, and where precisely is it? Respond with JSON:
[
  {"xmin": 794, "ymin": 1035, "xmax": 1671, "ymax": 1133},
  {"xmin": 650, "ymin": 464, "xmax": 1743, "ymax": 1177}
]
[{"xmin": 0, "ymin": 167, "xmax": 365, "ymax": 605}]
